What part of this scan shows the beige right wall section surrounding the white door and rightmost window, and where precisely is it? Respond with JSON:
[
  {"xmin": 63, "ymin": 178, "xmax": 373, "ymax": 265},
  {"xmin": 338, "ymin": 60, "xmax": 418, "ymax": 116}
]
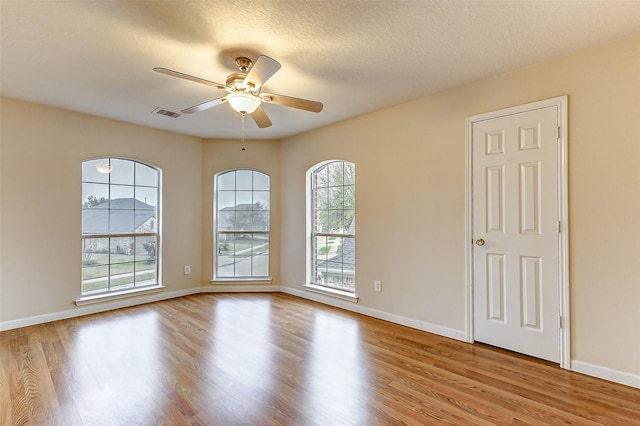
[{"xmin": 281, "ymin": 34, "xmax": 640, "ymax": 375}]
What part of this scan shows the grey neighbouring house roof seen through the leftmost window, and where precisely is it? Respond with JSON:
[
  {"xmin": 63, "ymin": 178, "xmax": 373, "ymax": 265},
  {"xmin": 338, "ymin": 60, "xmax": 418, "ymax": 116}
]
[{"xmin": 82, "ymin": 198, "xmax": 156, "ymax": 234}]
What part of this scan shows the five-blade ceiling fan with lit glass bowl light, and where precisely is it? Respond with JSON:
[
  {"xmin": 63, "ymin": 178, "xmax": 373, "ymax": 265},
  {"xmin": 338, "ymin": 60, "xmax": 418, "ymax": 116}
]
[{"xmin": 153, "ymin": 55, "xmax": 322, "ymax": 128}]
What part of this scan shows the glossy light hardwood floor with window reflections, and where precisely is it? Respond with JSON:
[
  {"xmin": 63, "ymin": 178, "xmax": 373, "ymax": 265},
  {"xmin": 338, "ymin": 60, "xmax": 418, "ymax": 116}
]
[{"xmin": 0, "ymin": 293, "xmax": 640, "ymax": 426}]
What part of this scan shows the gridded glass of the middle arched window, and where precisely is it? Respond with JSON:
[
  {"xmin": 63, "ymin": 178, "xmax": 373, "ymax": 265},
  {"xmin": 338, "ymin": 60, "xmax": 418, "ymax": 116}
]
[{"xmin": 214, "ymin": 169, "xmax": 270, "ymax": 279}]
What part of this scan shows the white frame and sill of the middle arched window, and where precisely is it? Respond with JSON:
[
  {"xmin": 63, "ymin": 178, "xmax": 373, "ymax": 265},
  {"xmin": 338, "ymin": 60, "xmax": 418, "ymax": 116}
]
[{"xmin": 209, "ymin": 167, "xmax": 273, "ymax": 285}]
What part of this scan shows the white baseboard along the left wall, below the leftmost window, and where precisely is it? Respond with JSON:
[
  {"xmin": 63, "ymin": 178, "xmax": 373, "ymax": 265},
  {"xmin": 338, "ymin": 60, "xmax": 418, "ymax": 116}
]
[{"xmin": 0, "ymin": 287, "xmax": 201, "ymax": 331}]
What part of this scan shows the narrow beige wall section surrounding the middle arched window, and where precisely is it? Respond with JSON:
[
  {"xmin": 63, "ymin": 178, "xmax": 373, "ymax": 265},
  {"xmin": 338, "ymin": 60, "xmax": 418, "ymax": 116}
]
[{"xmin": 202, "ymin": 139, "xmax": 280, "ymax": 286}]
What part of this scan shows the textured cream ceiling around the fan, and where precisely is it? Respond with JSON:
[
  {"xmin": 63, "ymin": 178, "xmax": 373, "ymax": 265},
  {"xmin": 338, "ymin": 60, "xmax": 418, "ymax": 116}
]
[{"xmin": 0, "ymin": 0, "xmax": 640, "ymax": 139}]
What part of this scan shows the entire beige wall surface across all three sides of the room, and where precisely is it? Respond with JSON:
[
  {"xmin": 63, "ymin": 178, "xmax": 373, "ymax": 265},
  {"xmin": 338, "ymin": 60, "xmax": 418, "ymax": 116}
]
[{"xmin": 0, "ymin": 34, "xmax": 640, "ymax": 375}]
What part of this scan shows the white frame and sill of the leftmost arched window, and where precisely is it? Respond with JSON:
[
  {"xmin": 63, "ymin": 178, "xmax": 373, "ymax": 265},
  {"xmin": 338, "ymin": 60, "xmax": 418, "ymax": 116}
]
[{"xmin": 80, "ymin": 155, "xmax": 165, "ymax": 298}]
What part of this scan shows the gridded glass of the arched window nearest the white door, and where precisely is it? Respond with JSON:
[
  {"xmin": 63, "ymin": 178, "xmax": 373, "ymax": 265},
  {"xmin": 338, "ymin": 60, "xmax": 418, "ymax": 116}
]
[{"xmin": 311, "ymin": 161, "xmax": 356, "ymax": 293}]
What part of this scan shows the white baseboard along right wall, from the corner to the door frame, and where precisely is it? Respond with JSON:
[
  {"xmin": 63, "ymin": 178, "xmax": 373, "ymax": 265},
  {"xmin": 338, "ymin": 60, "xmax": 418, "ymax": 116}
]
[{"xmin": 280, "ymin": 287, "xmax": 466, "ymax": 341}]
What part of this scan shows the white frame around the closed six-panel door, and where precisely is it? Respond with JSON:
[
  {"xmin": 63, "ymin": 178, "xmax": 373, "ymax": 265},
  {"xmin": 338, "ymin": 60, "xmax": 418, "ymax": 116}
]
[{"xmin": 464, "ymin": 96, "xmax": 571, "ymax": 369}]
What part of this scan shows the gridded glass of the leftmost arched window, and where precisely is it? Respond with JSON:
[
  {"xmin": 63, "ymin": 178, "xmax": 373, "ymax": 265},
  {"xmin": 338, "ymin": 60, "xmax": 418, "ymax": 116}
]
[{"xmin": 81, "ymin": 158, "xmax": 160, "ymax": 296}]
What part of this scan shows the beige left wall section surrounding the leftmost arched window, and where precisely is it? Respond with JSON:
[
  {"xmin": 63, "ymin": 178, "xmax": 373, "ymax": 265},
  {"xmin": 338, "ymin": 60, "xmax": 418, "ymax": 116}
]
[{"xmin": 0, "ymin": 98, "xmax": 202, "ymax": 321}]
